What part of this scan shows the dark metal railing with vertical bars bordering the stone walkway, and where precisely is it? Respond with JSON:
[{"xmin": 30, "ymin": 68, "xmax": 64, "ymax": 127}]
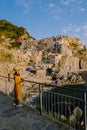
[{"xmin": 0, "ymin": 76, "xmax": 87, "ymax": 130}]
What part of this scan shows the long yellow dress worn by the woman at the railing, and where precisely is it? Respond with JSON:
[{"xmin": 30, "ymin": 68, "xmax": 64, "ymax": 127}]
[{"xmin": 14, "ymin": 75, "xmax": 22, "ymax": 100}]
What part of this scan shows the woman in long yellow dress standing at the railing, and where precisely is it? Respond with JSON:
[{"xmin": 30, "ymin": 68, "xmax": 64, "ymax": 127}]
[{"xmin": 14, "ymin": 70, "xmax": 23, "ymax": 106}]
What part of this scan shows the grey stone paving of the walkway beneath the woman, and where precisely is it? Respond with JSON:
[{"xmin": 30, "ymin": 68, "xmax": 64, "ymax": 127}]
[{"xmin": 0, "ymin": 92, "xmax": 69, "ymax": 130}]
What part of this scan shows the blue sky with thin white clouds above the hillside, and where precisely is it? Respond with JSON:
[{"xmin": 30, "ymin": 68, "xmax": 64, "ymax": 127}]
[{"xmin": 0, "ymin": 0, "xmax": 87, "ymax": 46}]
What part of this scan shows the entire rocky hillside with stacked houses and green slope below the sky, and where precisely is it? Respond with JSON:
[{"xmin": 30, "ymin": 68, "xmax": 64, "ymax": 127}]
[{"xmin": 0, "ymin": 20, "xmax": 87, "ymax": 85}]
